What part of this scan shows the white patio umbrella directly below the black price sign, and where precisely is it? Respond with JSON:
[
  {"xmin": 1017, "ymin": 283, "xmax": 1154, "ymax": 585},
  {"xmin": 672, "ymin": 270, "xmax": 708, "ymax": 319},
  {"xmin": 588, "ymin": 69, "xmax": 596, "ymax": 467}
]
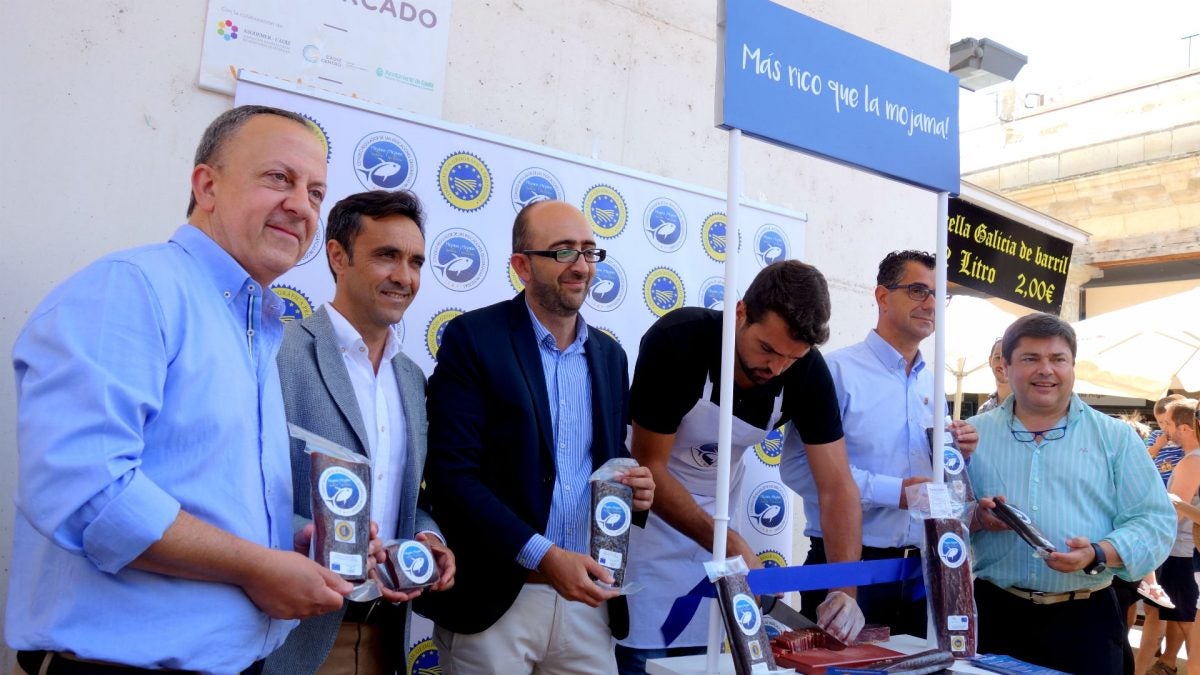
[{"xmin": 946, "ymin": 295, "xmax": 1032, "ymax": 419}]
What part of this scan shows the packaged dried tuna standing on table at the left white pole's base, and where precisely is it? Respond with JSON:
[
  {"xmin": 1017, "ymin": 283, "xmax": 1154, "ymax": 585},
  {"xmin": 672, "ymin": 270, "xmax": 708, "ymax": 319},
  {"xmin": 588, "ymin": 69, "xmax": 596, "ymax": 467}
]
[{"xmin": 704, "ymin": 556, "xmax": 775, "ymax": 675}]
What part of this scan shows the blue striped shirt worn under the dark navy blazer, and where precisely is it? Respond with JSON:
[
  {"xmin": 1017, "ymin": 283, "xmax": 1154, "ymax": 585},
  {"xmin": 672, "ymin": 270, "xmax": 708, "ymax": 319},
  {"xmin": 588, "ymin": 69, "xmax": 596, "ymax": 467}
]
[{"xmin": 517, "ymin": 305, "xmax": 592, "ymax": 569}]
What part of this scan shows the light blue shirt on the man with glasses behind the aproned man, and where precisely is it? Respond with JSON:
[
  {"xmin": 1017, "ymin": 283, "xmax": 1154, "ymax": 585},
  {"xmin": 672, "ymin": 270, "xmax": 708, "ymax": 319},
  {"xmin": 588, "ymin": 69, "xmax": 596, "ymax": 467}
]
[{"xmin": 780, "ymin": 330, "xmax": 934, "ymax": 548}]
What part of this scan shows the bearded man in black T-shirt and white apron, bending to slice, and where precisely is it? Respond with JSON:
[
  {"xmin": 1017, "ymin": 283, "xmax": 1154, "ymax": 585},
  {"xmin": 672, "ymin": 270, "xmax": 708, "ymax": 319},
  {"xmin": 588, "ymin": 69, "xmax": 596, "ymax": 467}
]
[{"xmin": 617, "ymin": 261, "xmax": 862, "ymax": 675}]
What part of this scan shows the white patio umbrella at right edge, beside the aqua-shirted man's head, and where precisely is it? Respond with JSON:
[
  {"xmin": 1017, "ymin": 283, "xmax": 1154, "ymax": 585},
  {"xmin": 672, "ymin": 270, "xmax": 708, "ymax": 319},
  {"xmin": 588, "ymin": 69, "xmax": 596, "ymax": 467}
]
[{"xmin": 1074, "ymin": 288, "xmax": 1200, "ymax": 400}]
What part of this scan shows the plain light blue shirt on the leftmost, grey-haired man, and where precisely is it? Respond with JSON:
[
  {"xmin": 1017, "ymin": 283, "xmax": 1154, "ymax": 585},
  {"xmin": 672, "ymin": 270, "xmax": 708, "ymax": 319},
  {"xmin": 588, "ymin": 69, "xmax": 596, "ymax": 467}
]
[{"xmin": 5, "ymin": 225, "xmax": 295, "ymax": 673}]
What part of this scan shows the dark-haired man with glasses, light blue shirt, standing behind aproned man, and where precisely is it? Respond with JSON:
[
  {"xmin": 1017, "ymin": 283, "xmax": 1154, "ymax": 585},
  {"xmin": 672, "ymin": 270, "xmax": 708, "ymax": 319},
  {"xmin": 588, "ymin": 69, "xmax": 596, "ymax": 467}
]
[{"xmin": 780, "ymin": 251, "xmax": 977, "ymax": 635}]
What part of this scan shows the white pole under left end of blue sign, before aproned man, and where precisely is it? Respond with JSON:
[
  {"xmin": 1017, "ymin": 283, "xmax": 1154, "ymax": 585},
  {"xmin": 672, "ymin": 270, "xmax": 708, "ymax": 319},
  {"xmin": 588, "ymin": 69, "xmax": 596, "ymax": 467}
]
[{"xmin": 706, "ymin": 129, "xmax": 742, "ymax": 675}]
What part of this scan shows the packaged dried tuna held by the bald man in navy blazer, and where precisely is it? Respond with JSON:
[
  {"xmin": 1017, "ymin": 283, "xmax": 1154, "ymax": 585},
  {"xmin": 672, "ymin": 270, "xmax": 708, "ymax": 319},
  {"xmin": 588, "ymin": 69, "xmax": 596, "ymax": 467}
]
[{"xmin": 590, "ymin": 458, "xmax": 637, "ymax": 587}]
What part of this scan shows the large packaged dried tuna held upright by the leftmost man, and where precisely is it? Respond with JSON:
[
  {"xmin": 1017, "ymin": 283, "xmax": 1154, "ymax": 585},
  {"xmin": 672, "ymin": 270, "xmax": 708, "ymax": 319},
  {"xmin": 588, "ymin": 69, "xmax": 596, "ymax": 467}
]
[{"xmin": 288, "ymin": 424, "xmax": 371, "ymax": 581}]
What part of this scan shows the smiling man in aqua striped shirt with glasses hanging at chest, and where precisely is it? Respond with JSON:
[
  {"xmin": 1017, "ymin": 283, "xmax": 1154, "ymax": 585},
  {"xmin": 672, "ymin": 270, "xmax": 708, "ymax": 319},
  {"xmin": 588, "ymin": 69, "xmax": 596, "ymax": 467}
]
[{"xmin": 967, "ymin": 313, "xmax": 1176, "ymax": 675}]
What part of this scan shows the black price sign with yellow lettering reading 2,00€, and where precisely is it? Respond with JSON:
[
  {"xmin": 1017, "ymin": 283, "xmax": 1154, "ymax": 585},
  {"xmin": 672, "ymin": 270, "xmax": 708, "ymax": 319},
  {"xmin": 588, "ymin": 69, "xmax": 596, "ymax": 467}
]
[{"xmin": 946, "ymin": 197, "xmax": 1072, "ymax": 313}]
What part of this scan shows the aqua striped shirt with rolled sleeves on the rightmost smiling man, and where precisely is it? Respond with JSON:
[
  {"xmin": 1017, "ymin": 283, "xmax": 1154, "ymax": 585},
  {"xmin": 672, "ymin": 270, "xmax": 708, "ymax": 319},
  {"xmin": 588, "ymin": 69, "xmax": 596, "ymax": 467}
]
[{"xmin": 967, "ymin": 395, "xmax": 1176, "ymax": 592}]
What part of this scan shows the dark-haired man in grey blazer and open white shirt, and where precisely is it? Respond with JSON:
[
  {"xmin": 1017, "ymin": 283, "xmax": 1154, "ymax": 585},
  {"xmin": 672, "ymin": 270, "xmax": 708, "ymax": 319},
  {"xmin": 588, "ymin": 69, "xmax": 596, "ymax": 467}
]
[{"xmin": 266, "ymin": 191, "xmax": 455, "ymax": 675}]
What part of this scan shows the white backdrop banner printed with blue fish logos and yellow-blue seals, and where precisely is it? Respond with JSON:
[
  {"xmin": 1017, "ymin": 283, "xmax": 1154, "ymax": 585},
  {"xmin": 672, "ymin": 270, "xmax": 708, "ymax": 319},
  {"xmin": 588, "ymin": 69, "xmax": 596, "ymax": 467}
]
[{"xmin": 235, "ymin": 73, "xmax": 805, "ymax": 674}]
